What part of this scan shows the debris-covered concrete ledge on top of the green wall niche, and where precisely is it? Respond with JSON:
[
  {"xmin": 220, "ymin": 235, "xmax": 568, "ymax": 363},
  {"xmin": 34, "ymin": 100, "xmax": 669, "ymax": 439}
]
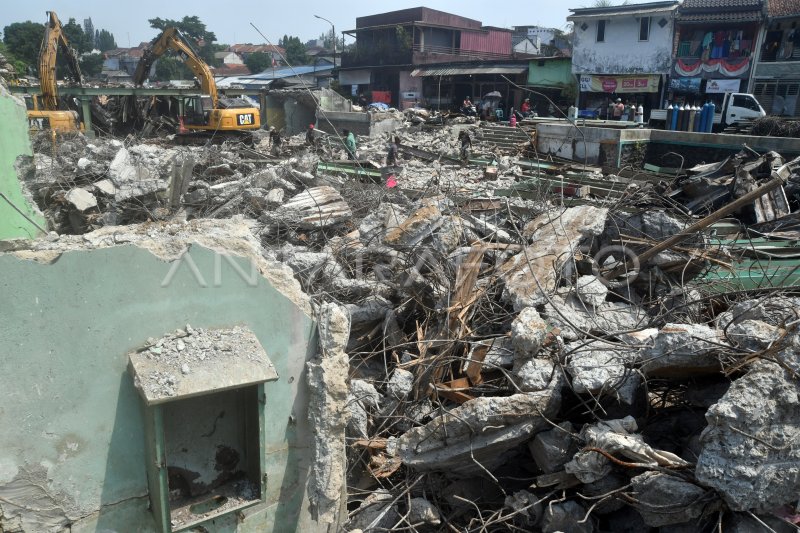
[{"xmin": 128, "ymin": 326, "xmax": 278, "ymax": 406}]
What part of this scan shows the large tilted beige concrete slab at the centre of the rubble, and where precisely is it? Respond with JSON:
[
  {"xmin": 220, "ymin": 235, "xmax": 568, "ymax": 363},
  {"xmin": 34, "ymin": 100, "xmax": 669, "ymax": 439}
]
[{"xmin": 500, "ymin": 206, "xmax": 608, "ymax": 310}]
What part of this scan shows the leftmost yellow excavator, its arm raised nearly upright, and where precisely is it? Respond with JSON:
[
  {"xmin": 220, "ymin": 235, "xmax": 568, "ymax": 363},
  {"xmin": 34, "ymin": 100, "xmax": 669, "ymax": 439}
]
[{"xmin": 28, "ymin": 11, "xmax": 83, "ymax": 133}]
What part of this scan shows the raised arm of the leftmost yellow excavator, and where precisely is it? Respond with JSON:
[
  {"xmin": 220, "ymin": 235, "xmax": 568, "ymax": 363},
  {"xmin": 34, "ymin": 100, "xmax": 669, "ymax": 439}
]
[{"xmin": 39, "ymin": 11, "xmax": 83, "ymax": 111}]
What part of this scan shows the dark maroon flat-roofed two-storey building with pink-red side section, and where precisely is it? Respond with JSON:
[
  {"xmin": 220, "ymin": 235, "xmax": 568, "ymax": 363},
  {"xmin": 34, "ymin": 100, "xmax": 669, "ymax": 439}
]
[{"xmin": 339, "ymin": 7, "xmax": 512, "ymax": 107}]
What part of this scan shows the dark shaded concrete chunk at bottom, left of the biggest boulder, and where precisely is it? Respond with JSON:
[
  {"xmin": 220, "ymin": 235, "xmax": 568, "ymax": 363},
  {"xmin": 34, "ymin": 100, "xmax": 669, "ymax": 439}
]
[{"xmin": 631, "ymin": 472, "xmax": 713, "ymax": 527}]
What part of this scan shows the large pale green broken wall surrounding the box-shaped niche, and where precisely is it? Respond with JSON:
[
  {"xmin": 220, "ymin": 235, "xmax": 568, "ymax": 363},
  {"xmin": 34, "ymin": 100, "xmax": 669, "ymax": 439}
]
[{"xmin": 0, "ymin": 245, "xmax": 317, "ymax": 533}]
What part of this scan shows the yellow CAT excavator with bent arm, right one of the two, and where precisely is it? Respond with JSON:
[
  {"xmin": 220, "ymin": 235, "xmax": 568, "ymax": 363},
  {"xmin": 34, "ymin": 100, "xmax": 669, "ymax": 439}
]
[{"xmin": 133, "ymin": 28, "xmax": 261, "ymax": 139}]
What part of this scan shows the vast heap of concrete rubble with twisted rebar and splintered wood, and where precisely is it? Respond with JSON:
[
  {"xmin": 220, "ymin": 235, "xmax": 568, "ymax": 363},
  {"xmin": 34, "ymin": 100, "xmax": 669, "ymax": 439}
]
[{"xmin": 9, "ymin": 116, "xmax": 800, "ymax": 533}]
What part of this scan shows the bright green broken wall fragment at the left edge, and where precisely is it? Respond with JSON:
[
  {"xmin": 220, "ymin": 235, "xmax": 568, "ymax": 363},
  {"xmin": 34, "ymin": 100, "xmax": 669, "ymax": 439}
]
[{"xmin": 0, "ymin": 84, "xmax": 46, "ymax": 240}]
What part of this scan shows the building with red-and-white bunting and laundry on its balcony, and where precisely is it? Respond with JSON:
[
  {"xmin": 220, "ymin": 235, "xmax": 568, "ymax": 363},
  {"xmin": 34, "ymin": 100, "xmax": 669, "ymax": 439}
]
[{"xmin": 667, "ymin": 0, "xmax": 765, "ymax": 104}]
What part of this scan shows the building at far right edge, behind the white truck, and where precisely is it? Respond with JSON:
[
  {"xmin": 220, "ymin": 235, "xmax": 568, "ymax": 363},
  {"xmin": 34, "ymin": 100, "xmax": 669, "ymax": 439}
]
[{"xmin": 748, "ymin": 0, "xmax": 800, "ymax": 117}]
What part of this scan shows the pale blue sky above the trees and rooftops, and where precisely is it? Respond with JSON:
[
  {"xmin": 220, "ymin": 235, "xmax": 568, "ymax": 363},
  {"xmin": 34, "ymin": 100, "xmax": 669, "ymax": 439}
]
[{"xmin": 0, "ymin": 0, "xmax": 652, "ymax": 47}]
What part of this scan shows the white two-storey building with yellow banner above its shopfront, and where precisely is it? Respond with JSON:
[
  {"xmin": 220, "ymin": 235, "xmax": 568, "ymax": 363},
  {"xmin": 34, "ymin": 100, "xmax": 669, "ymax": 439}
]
[{"xmin": 567, "ymin": 1, "xmax": 678, "ymax": 118}]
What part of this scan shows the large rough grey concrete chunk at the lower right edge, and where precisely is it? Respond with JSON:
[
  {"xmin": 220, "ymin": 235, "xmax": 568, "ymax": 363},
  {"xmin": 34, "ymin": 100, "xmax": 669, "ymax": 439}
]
[{"xmin": 695, "ymin": 358, "xmax": 800, "ymax": 512}]
